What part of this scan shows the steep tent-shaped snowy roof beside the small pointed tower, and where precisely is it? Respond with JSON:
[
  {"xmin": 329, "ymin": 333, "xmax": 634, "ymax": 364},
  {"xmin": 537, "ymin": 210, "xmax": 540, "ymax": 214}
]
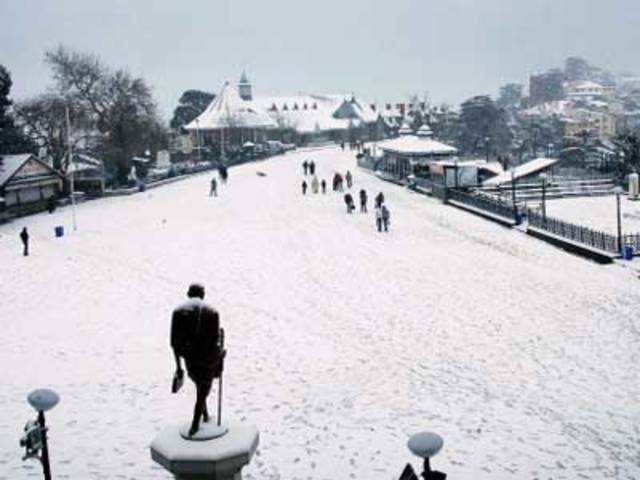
[{"xmin": 185, "ymin": 82, "xmax": 276, "ymax": 130}]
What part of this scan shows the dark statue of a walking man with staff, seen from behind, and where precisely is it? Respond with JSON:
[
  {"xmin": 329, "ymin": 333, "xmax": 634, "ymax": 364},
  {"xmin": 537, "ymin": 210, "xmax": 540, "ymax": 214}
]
[{"xmin": 171, "ymin": 284, "xmax": 226, "ymax": 437}]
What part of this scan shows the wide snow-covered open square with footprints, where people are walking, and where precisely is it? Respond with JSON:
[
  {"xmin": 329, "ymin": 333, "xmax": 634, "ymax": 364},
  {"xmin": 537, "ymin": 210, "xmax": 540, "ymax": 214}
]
[{"xmin": 0, "ymin": 149, "xmax": 640, "ymax": 480}]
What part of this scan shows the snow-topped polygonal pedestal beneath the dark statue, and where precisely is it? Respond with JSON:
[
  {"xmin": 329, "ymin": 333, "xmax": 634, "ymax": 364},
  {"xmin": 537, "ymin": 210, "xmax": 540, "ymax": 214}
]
[{"xmin": 151, "ymin": 423, "xmax": 259, "ymax": 480}]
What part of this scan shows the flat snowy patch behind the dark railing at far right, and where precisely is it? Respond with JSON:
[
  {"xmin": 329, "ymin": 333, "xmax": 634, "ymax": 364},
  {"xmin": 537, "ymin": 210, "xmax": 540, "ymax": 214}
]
[{"xmin": 547, "ymin": 195, "xmax": 640, "ymax": 235}]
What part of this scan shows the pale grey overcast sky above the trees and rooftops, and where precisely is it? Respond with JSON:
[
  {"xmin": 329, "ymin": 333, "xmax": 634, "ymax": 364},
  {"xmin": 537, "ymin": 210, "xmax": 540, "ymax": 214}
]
[{"xmin": 0, "ymin": 0, "xmax": 640, "ymax": 117}]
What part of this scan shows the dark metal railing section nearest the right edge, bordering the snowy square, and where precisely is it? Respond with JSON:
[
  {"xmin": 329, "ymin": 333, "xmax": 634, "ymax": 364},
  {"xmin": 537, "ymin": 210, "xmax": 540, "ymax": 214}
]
[{"xmin": 527, "ymin": 210, "xmax": 620, "ymax": 254}]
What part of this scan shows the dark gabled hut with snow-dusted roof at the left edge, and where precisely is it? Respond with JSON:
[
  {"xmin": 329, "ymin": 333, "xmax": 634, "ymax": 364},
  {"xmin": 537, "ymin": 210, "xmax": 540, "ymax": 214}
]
[{"xmin": 0, "ymin": 153, "xmax": 63, "ymax": 216}]
